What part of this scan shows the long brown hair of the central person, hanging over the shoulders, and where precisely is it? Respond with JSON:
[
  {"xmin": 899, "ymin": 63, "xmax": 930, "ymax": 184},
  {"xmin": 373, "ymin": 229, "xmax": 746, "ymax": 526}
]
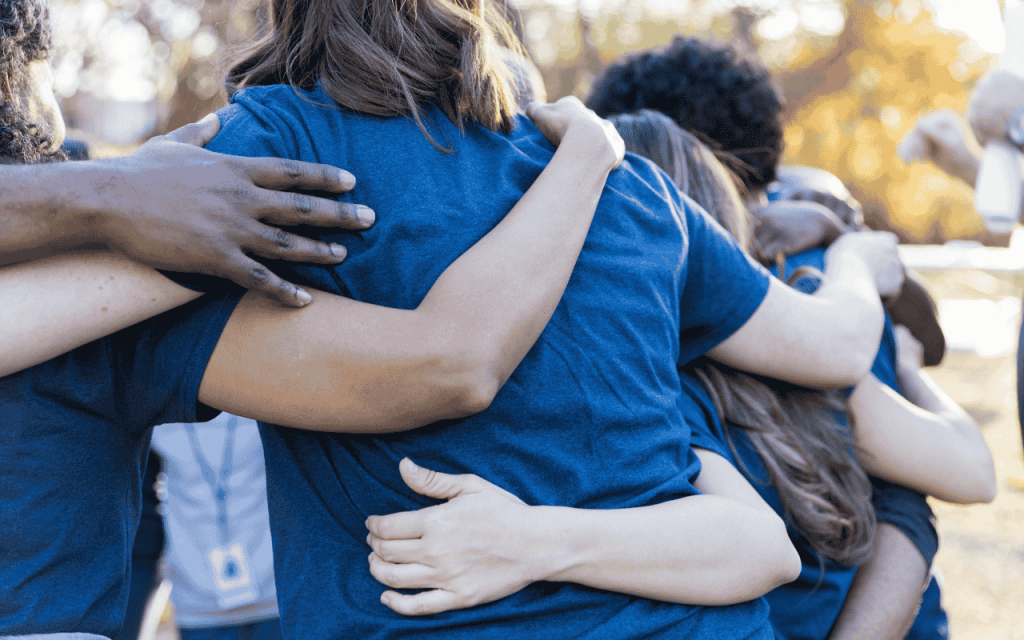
[{"xmin": 224, "ymin": 0, "xmax": 522, "ymax": 148}]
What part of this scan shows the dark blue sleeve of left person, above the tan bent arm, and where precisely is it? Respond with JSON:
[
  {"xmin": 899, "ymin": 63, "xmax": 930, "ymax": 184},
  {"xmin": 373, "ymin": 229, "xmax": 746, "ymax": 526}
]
[{"xmin": 110, "ymin": 292, "xmax": 243, "ymax": 431}]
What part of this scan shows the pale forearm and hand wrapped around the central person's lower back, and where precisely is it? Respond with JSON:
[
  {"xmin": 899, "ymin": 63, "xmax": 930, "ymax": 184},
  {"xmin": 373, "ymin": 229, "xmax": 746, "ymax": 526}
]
[{"xmin": 367, "ymin": 452, "xmax": 800, "ymax": 615}]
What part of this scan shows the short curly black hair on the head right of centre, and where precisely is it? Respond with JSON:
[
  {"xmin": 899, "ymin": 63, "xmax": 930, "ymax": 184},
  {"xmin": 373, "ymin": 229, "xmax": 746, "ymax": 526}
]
[{"xmin": 587, "ymin": 36, "xmax": 784, "ymax": 190}]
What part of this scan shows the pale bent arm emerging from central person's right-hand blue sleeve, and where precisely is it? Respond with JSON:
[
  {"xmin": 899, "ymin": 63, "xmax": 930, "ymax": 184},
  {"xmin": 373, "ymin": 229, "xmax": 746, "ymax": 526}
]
[{"xmin": 708, "ymin": 231, "xmax": 902, "ymax": 388}]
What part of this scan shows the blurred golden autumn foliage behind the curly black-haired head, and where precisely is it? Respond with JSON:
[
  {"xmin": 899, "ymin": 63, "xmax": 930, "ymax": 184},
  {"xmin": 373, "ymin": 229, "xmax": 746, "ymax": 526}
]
[{"xmin": 512, "ymin": 0, "xmax": 997, "ymax": 243}]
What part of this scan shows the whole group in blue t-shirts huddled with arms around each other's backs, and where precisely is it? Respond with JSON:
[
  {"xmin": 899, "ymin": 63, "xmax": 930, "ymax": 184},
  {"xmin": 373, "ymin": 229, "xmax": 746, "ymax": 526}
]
[{"xmin": 0, "ymin": 0, "xmax": 1015, "ymax": 640}]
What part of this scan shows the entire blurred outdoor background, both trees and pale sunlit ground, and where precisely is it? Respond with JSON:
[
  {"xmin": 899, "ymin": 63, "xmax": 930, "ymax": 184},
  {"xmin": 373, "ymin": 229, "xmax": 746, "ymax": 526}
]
[{"xmin": 52, "ymin": 0, "xmax": 1024, "ymax": 640}]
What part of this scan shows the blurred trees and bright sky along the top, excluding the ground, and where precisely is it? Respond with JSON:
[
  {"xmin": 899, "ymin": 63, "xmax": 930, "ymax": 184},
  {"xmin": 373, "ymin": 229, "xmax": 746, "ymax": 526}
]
[{"xmin": 52, "ymin": 0, "xmax": 1024, "ymax": 244}]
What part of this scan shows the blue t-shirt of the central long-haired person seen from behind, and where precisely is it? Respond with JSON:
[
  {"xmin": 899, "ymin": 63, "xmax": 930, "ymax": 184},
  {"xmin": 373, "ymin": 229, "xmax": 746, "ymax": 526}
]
[{"xmin": 208, "ymin": 86, "xmax": 771, "ymax": 640}]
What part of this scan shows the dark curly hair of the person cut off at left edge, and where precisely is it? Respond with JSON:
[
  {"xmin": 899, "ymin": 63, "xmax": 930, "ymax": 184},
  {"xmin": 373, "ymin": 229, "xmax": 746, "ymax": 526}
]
[{"xmin": 0, "ymin": 0, "xmax": 60, "ymax": 164}]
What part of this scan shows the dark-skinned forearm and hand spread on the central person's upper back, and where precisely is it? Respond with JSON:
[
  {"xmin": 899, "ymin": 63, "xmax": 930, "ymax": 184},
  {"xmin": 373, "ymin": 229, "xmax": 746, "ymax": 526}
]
[{"xmin": 0, "ymin": 116, "xmax": 373, "ymax": 306}]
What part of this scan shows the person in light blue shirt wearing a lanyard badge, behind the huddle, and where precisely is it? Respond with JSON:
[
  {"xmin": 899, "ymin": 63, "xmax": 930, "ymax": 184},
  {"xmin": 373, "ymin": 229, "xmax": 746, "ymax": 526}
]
[{"xmin": 153, "ymin": 413, "xmax": 282, "ymax": 640}]
